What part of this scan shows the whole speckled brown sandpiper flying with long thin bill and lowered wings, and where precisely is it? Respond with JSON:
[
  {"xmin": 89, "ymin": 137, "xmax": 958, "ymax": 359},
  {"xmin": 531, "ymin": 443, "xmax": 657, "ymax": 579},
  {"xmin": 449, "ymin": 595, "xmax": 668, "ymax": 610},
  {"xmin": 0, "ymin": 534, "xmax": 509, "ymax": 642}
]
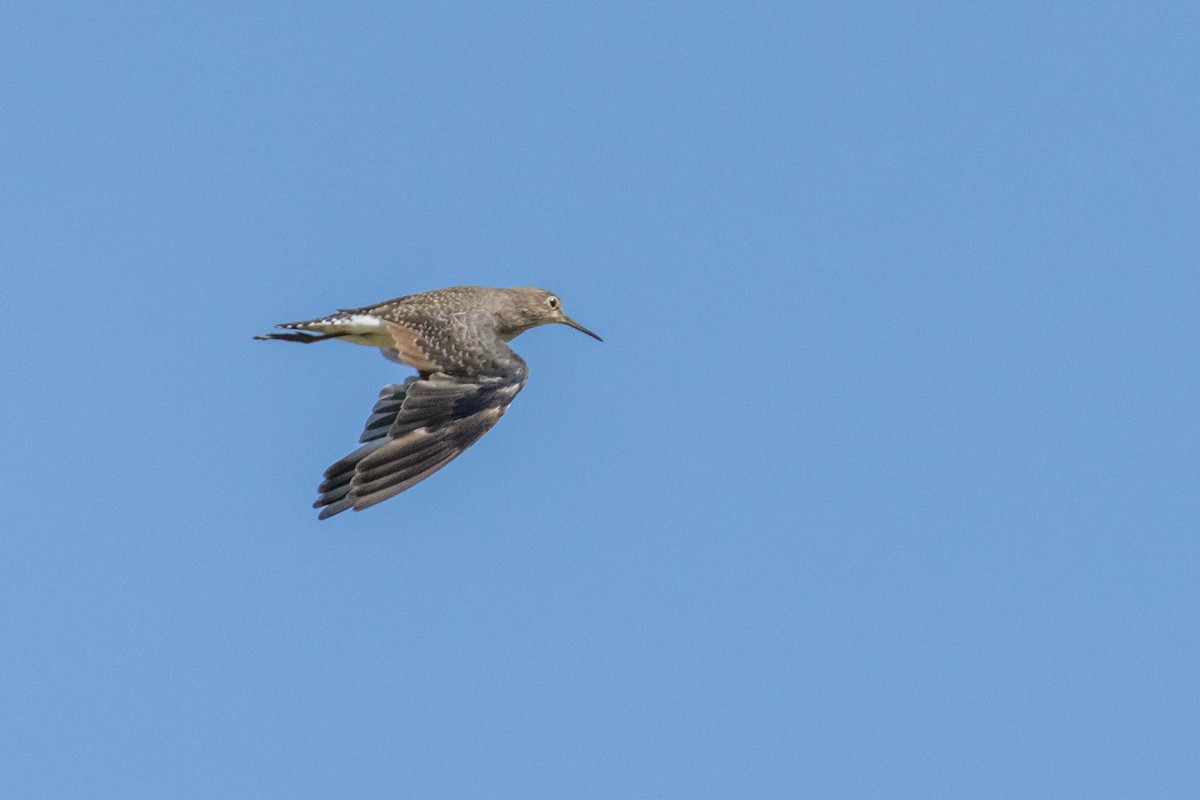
[{"xmin": 254, "ymin": 287, "xmax": 602, "ymax": 519}]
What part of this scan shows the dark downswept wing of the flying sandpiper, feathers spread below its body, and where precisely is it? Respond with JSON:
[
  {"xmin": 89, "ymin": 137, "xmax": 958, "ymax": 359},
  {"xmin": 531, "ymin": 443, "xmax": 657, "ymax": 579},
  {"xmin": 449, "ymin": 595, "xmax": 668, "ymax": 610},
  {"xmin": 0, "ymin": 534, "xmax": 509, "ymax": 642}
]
[{"xmin": 313, "ymin": 362, "xmax": 528, "ymax": 519}]
